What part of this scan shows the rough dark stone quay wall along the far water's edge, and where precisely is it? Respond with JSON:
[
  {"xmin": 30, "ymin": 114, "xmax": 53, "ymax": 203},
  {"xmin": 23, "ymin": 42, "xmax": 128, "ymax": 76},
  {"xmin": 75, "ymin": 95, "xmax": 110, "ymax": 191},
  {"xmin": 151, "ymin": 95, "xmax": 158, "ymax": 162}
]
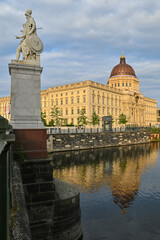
[{"xmin": 47, "ymin": 131, "xmax": 150, "ymax": 152}]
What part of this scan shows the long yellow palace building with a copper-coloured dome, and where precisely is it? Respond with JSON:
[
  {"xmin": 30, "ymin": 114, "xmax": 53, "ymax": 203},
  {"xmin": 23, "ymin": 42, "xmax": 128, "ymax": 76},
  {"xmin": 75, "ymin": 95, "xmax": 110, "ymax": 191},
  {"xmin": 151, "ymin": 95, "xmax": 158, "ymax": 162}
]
[{"xmin": 0, "ymin": 54, "xmax": 157, "ymax": 126}]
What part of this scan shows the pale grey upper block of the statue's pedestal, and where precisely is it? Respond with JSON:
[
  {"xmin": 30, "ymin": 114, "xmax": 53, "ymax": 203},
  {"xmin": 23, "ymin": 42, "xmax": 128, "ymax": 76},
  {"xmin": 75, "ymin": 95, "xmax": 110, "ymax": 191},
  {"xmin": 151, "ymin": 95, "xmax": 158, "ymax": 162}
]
[{"xmin": 9, "ymin": 62, "xmax": 44, "ymax": 129}]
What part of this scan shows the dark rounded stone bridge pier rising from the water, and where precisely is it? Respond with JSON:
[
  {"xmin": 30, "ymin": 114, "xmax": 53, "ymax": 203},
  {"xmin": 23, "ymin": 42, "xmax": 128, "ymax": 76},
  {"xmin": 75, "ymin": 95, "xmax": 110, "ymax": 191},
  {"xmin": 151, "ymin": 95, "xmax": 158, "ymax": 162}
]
[{"xmin": 21, "ymin": 159, "xmax": 82, "ymax": 240}]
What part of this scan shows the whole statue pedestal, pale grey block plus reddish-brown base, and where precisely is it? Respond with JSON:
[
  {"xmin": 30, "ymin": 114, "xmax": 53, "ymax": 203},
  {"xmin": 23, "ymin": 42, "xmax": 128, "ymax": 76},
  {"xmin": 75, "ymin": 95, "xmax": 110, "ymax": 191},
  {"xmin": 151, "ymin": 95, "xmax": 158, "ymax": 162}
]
[{"xmin": 9, "ymin": 60, "xmax": 48, "ymax": 159}]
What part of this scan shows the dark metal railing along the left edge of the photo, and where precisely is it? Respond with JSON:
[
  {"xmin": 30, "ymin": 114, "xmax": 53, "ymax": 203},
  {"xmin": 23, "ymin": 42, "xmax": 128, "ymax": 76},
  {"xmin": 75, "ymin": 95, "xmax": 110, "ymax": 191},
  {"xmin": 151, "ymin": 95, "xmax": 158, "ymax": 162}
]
[{"xmin": 0, "ymin": 116, "xmax": 14, "ymax": 240}]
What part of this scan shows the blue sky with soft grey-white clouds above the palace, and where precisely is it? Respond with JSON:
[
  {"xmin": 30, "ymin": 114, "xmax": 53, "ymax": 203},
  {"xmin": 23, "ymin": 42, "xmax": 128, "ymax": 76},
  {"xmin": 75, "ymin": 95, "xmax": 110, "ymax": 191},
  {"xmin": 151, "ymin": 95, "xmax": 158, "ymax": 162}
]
[{"xmin": 0, "ymin": 0, "xmax": 160, "ymax": 107}]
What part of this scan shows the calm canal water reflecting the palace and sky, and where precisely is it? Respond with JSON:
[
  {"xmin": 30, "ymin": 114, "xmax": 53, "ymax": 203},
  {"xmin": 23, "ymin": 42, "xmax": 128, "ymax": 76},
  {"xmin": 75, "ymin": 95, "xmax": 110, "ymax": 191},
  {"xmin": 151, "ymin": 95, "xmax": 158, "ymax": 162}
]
[{"xmin": 50, "ymin": 143, "xmax": 160, "ymax": 240}]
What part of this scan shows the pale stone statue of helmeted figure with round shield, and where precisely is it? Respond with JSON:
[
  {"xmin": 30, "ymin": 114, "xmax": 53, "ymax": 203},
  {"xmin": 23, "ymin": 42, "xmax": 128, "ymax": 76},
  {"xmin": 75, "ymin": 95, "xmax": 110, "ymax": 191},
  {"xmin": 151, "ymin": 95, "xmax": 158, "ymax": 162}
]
[{"xmin": 16, "ymin": 9, "xmax": 43, "ymax": 62}]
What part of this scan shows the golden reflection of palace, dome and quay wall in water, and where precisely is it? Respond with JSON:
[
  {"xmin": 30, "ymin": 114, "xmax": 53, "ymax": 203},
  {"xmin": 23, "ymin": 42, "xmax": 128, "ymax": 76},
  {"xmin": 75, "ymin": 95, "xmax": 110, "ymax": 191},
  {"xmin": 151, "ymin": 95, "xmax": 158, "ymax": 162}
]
[{"xmin": 53, "ymin": 143, "xmax": 159, "ymax": 214}]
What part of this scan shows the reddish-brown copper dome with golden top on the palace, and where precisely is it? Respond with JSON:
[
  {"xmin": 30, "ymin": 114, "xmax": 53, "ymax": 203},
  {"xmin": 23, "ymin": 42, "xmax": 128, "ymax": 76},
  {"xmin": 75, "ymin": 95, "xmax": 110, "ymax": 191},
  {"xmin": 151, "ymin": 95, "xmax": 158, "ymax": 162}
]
[{"xmin": 110, "ymin": 54, "xmax": 136, "ymax": 77}]
